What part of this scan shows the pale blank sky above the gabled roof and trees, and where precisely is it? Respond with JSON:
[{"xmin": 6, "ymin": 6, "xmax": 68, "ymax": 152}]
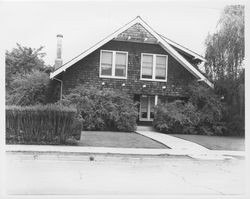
[{"xmin": 0, "ymin": 1, "xmax": 244, "ymax": 65}]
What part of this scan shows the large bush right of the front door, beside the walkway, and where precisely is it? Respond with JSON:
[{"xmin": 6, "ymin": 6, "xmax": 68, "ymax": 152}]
[{"xmin": 153, "ymin": 82, "xmax": 227, "ymax": 135}]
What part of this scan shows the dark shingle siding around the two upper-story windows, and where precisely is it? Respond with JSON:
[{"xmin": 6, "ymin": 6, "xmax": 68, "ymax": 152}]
[{"xmin": 61, "ymin": 40, "xmax": 194, "ymax": 96}]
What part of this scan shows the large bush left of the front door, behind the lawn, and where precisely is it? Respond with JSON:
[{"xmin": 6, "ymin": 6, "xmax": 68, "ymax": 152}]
[{"xmin": 60, "ymin": 86, "xmax": 138, "ymax": 132}]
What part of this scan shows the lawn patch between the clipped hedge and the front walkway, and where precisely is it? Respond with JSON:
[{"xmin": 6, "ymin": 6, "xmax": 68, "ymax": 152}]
[{"xmin": 78, "ymin": 131, "xmax": 168, "ymax": 149}]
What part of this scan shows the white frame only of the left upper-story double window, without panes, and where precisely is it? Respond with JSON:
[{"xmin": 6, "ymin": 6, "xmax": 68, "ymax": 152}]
[{"xmin": 99, "ymin": 50, "xmax": 128, "ymax": 79}]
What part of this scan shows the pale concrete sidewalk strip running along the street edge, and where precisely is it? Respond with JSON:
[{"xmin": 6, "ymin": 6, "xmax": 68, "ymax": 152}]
[{"xmin": 5, "ymin": 145, "xmax": 245, "ymax": 160}]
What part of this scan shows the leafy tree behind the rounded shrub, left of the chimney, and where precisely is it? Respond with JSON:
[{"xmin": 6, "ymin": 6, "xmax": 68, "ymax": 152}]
[{"xmin": 5, "ymin": 43, "xmax": 46, "ymax": 92}]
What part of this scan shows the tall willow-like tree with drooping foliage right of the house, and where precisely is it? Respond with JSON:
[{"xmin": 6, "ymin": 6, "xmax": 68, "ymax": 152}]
[{"xmin": 205, "ymin": 5, "xmax": 245, "ymax": 135}]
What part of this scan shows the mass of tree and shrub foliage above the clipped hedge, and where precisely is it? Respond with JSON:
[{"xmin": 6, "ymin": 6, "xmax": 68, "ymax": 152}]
[{"xmin": 5, "ymin": 44, "xmax": 55, "ymax": 106}]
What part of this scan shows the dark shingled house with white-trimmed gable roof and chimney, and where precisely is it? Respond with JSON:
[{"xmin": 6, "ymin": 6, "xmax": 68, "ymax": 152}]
[{"xmin": 50, "ymin": 17, "xmax": 213, "ymax": 122}]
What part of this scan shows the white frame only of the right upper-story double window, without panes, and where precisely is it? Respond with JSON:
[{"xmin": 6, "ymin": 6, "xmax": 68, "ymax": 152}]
[{"xmin": 140, "ymin": 53, "xmax": 168, "ymax": 82}]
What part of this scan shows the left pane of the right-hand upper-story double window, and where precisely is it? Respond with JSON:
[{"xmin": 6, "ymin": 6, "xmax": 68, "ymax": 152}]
[{"xmin": 142, "ymin": 55, "xmax": 153, "ymax": 79}]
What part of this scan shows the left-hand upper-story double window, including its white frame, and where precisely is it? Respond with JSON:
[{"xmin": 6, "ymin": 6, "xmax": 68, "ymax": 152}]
[{"xmin": 100, "ymin": 50, "xmax": 128, "ymax": 79}]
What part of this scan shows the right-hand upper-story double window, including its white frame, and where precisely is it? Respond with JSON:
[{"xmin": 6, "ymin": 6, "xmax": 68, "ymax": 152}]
[{"xmin": 141, "ymin": 53, "xmax": 168, "ymax": 81}]
